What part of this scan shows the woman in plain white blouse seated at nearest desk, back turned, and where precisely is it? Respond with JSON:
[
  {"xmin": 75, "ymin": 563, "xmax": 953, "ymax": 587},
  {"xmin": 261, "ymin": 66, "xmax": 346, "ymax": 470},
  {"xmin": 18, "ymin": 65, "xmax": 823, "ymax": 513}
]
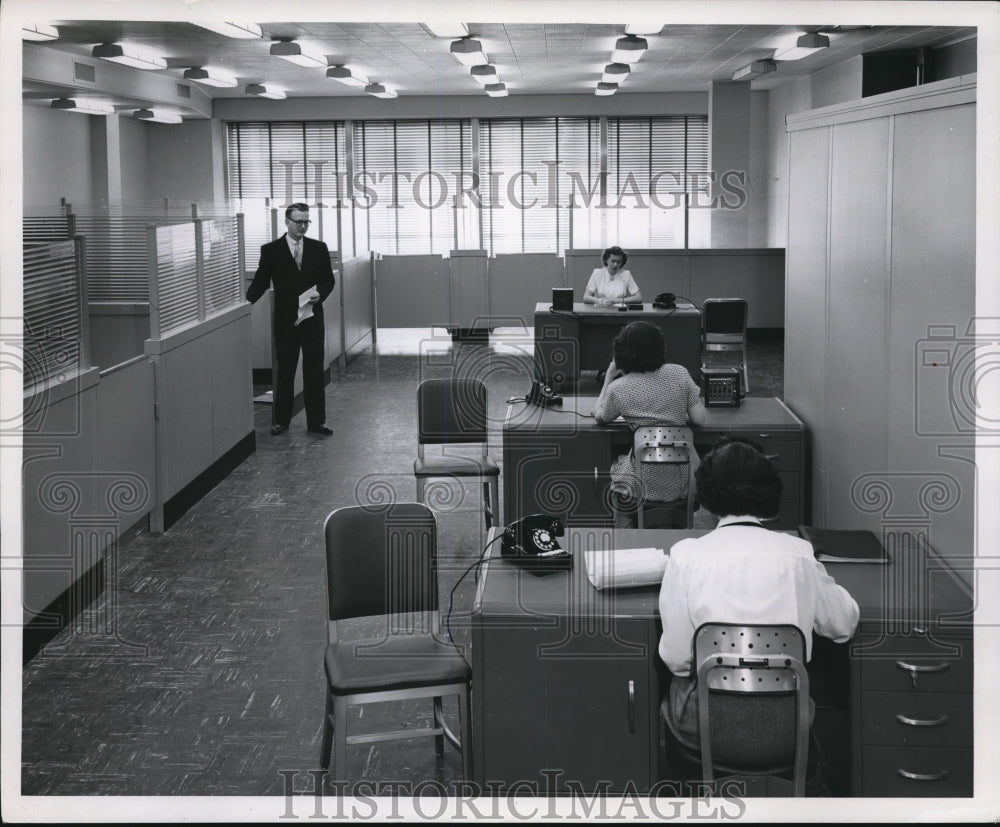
[{"xmin": 659, "ymin": 438, "xmax": 859, "ymax": 750}]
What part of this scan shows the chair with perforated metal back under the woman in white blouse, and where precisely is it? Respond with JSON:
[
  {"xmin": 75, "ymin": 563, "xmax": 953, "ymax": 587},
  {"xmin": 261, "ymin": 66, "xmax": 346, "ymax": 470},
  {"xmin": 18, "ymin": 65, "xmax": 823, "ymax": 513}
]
[{"xmin": 661, "ymin": 623, "xmax": 816, "ymax": 796}]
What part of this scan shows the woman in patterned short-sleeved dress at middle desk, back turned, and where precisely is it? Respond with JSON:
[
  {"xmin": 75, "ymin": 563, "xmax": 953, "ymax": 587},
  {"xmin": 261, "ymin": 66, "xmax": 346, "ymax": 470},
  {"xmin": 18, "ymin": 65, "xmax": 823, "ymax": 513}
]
[{"xmin": 594, "ymin": 322, "xmax": 705, "ymax": 528}]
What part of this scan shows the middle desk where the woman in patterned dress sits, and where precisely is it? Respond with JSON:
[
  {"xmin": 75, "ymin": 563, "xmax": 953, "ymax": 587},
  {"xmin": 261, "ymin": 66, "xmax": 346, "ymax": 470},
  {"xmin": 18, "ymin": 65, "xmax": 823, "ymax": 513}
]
[{"xmin": 503, "ymin": 396, "xmax": 808, "ymax": 529}]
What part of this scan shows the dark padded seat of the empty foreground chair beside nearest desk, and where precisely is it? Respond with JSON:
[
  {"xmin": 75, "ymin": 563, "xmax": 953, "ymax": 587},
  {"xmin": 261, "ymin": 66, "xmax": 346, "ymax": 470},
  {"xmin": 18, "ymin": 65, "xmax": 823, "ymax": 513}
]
[{"xmin": 324, "ymin": 634, "xmax": 472, "ymax": 695}]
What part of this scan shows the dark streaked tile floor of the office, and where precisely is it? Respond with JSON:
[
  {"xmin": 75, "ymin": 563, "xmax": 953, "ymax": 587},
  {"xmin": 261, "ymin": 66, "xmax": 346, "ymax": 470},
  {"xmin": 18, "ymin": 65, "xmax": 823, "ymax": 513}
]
[{"xmin": 22, "ymin": 330, "xmax": 782, "ymax": 796}]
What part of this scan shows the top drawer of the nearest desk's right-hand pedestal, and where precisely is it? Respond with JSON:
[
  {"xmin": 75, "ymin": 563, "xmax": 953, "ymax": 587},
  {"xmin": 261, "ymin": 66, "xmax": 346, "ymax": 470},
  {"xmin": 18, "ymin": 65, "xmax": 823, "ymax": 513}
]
[{"xmin": 852, "ymin": 637, "xmax": 973, "ymax": 693}]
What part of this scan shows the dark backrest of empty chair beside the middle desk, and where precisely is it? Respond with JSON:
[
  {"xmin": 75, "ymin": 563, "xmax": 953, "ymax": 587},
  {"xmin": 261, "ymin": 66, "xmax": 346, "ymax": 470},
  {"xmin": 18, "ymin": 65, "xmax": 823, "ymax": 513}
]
[{"xmin": 417, "ymin": 379, "xmax": 487, "ymax": 445}]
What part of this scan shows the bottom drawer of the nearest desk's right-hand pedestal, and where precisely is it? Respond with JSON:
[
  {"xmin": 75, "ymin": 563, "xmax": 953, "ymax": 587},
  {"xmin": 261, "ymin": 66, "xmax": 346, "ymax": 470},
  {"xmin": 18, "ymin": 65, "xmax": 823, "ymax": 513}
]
[{"xmin": 861, "ymin": 747, "xmax": 972, "ymax": 798}]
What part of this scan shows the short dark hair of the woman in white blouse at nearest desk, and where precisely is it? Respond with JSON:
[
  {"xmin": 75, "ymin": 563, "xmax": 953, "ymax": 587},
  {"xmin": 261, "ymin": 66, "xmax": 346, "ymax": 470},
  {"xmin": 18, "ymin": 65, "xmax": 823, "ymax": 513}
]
[{"xmin": 694, "ymin": 437, "xmax": 781, "ymax": 519}]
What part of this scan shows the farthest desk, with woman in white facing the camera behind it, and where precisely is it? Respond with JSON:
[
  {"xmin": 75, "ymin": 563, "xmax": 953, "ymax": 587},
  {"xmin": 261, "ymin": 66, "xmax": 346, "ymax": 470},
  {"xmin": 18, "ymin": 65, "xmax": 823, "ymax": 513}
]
[{"xmin": 535, "ymin": 302, "xmax": 701, "ymax": 385}]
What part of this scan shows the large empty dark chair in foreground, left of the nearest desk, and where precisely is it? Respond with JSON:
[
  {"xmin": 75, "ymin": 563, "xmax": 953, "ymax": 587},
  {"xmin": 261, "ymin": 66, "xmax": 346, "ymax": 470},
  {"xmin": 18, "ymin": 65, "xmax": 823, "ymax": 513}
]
[{"xmin": 320, "ymin": 503, "xmax": 472, "ymax": 779}]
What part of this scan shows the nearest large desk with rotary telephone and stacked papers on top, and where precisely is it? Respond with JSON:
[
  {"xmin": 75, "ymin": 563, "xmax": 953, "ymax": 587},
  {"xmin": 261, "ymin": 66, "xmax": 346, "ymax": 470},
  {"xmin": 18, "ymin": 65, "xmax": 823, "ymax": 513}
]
[{"xmin": 472, "ymin": 528, "xmax": 972, "ymax": 796}]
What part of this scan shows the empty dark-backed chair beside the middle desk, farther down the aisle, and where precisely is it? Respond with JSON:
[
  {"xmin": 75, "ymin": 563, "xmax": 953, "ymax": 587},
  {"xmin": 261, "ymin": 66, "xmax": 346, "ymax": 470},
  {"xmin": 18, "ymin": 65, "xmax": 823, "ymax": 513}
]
[{"xmin": 413, "ymin": 379, "xmax": 500, "ymax": 531}]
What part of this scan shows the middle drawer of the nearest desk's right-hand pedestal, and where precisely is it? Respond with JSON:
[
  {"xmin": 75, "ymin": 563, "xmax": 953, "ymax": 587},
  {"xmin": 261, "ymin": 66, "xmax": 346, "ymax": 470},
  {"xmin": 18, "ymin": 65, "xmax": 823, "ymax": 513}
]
[{"xmin": 861, "ymin": 692, "xmax": 972, "ymax": 747}]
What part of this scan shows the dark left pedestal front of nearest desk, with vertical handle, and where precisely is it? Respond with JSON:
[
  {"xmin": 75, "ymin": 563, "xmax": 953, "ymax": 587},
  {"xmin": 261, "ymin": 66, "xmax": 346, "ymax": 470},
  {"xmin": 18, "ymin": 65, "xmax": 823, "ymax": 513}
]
[{"xmin": 476, "ymin": 618, "xmax": 659, "ymax": 794}]
